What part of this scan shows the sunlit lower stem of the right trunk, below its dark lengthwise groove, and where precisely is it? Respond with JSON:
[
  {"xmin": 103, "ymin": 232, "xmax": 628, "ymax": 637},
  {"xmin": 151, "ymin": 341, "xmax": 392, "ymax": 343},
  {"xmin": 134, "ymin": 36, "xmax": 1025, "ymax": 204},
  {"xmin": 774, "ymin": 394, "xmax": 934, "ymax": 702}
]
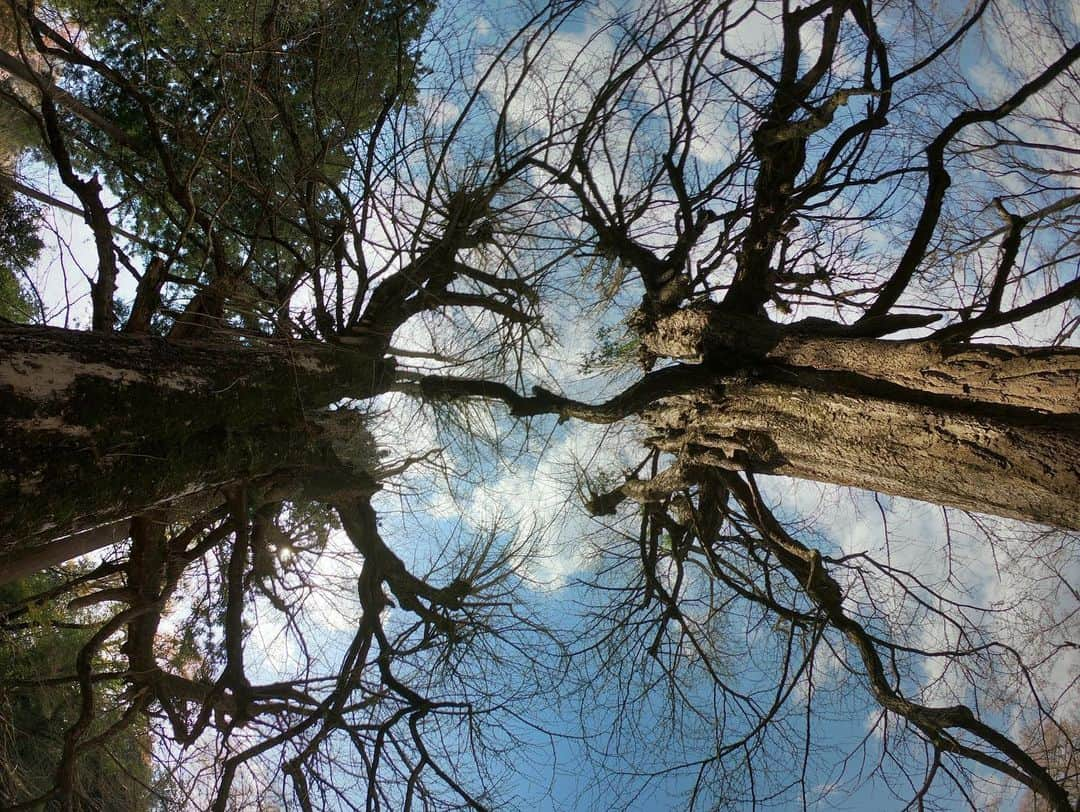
[{"xmin": 645, "ymin": 382, "xmax": 1080, "ymax": 528}]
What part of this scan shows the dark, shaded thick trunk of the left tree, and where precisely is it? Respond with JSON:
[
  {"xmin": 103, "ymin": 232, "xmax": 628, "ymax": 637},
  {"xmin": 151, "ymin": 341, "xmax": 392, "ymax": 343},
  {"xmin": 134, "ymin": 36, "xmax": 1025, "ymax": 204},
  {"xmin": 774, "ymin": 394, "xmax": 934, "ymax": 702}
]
[{"xmin": 0, "ymin": 327, "xmax": 392, "ymax": 554}]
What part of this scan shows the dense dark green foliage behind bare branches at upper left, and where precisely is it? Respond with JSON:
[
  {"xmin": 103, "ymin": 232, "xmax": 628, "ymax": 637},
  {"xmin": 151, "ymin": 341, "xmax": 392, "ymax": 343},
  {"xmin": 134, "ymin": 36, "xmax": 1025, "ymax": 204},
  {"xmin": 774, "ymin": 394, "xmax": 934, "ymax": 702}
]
[{"xmin": 65, "ymin": 0, "xmax": 432, "ymax": 323}]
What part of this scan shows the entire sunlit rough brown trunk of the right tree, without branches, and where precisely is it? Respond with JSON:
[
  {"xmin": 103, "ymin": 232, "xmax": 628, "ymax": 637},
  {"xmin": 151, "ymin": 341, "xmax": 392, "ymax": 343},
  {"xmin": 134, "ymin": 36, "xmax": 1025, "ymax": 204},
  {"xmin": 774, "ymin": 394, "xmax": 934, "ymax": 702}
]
[{"xmin": 645, "ymin": 310, "xmax": 1080, "ymax": 528}]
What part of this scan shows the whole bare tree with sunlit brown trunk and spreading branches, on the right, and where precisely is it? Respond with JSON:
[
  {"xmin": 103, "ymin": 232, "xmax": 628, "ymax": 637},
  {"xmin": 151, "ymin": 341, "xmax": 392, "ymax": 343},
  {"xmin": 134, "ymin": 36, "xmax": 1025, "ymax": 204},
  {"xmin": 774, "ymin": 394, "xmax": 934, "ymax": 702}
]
[{"xmin": 412, "ymin": 3, "xmax": 1080, "ymax": 810}]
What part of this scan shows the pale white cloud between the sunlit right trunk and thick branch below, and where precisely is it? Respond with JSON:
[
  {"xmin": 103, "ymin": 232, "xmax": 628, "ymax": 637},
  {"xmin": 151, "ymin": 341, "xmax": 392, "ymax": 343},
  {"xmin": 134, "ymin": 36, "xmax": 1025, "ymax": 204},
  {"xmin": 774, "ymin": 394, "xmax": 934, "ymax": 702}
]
[{"xmin": 762, "ymin": 478, "xmax": 1080, "ymax": 721}]
